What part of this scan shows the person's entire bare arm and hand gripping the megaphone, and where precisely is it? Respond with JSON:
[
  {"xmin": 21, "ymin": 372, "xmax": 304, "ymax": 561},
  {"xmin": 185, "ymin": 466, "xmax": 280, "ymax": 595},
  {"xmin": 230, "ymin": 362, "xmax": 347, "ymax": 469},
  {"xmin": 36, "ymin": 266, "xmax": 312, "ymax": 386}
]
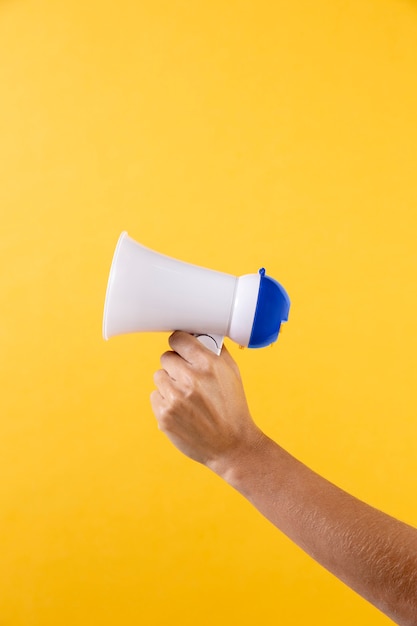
[{"xmin": 151, "ymin": 332, "xmax": 417, "ymax": 626}]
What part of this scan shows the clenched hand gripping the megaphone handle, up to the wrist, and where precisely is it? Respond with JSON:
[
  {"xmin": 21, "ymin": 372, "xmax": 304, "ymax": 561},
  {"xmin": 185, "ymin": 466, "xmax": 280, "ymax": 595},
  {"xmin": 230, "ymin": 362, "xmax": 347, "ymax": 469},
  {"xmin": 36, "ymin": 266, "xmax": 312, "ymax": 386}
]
[{"xmin": 151, "ymin": 332, "xmax": 263, "ymax": 473}]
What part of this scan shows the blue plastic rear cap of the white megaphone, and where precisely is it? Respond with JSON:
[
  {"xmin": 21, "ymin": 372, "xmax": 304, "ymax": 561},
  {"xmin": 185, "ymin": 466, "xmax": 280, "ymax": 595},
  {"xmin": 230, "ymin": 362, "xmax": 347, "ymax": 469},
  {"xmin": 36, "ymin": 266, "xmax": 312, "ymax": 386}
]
[{"xmin": 248, "ymin": 268, "xmax": 290, "ymax": 348}]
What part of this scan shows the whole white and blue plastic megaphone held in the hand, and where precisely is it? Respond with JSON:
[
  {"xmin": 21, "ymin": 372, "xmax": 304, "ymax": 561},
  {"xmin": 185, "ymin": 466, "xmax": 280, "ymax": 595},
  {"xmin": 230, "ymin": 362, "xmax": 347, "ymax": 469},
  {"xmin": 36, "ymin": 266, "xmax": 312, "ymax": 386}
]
[{"xmin": 103, "ymin": 232, "xmax": 290, "ymax": 354}]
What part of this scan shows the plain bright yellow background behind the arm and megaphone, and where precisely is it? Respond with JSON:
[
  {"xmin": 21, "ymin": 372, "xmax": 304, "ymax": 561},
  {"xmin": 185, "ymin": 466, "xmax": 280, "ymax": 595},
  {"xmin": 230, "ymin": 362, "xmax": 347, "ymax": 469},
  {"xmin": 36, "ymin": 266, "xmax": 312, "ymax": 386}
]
[{"xmin": 0, "ymin": 0, "xmax": 417, "ymax": 626}]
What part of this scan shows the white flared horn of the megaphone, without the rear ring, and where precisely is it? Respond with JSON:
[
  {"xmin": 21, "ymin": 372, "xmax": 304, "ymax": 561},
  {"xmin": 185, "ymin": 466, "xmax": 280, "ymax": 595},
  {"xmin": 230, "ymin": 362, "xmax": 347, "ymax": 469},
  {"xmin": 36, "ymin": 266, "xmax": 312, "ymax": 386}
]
[{"xmin": 103, "ymin": 233, "xmax": 238, "ymax": 339}]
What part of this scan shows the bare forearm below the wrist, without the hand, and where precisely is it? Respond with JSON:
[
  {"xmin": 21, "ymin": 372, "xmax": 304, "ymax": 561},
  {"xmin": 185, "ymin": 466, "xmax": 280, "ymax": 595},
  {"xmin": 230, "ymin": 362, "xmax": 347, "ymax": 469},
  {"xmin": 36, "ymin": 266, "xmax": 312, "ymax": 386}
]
[{"xmin": 212, "ymin": 437, "xmax": 417, "ymax": 625}]
